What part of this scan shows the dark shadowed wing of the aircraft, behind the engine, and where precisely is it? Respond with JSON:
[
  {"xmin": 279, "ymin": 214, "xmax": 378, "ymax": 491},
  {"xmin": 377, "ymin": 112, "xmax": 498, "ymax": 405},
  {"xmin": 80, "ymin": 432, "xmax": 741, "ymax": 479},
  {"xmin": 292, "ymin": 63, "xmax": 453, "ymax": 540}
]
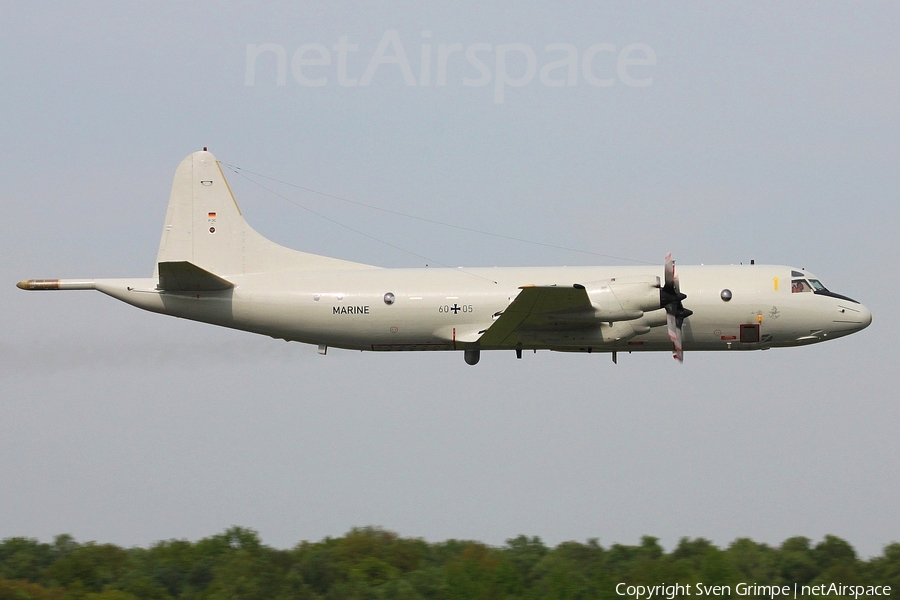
[{"xmin": 478, "ymin": 283, "xmax": 595, "ymax": 347}]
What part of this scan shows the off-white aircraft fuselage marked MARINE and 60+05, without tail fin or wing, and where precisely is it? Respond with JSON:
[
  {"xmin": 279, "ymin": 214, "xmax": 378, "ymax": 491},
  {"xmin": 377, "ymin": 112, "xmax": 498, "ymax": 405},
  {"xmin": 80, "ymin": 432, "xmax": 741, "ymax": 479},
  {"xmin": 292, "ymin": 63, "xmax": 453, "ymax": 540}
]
[{"xmin": 81, "ymin": 265, "xmax": 871, "ymax": 352}]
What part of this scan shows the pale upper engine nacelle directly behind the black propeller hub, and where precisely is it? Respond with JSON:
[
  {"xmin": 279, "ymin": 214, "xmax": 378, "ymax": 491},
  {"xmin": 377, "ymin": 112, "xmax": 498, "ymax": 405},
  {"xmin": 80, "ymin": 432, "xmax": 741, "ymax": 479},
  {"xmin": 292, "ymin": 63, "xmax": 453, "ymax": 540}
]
[{"xmin": 584, "ymin": 277, "xmax": 661, "ymax": 321}]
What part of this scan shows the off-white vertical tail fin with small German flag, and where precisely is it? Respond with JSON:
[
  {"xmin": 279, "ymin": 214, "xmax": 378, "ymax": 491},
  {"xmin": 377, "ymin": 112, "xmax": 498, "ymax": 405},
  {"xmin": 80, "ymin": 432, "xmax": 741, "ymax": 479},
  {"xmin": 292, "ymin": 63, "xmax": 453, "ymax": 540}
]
[{"xmin": 153, "ymin": 149, "xmax": 374, "ymax": 277}]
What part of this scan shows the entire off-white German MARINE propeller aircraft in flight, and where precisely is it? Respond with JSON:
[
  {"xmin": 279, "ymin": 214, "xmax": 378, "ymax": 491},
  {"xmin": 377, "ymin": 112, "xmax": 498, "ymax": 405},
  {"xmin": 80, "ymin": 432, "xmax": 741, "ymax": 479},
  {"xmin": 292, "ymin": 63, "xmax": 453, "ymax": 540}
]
[{"xmin": 18, "ymin": 148, "xmax": 872, "ymax": 365}]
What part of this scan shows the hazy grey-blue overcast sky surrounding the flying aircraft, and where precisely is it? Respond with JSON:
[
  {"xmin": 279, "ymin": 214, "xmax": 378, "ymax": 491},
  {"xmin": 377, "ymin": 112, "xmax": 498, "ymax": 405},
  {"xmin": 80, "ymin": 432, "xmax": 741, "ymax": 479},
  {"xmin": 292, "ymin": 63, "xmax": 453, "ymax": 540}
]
[{"xmin": 0, "ymin": 1, "xmax": 900, "ymax": 556}]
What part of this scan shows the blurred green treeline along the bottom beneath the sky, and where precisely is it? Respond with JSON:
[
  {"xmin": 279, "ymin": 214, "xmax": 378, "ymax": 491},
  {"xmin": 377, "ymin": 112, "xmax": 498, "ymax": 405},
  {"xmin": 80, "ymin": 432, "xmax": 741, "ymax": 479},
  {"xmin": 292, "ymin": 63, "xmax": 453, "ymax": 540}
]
[{"xmin": 0, "ymin": 527, "xmax": 900, "ymax": 600}]
